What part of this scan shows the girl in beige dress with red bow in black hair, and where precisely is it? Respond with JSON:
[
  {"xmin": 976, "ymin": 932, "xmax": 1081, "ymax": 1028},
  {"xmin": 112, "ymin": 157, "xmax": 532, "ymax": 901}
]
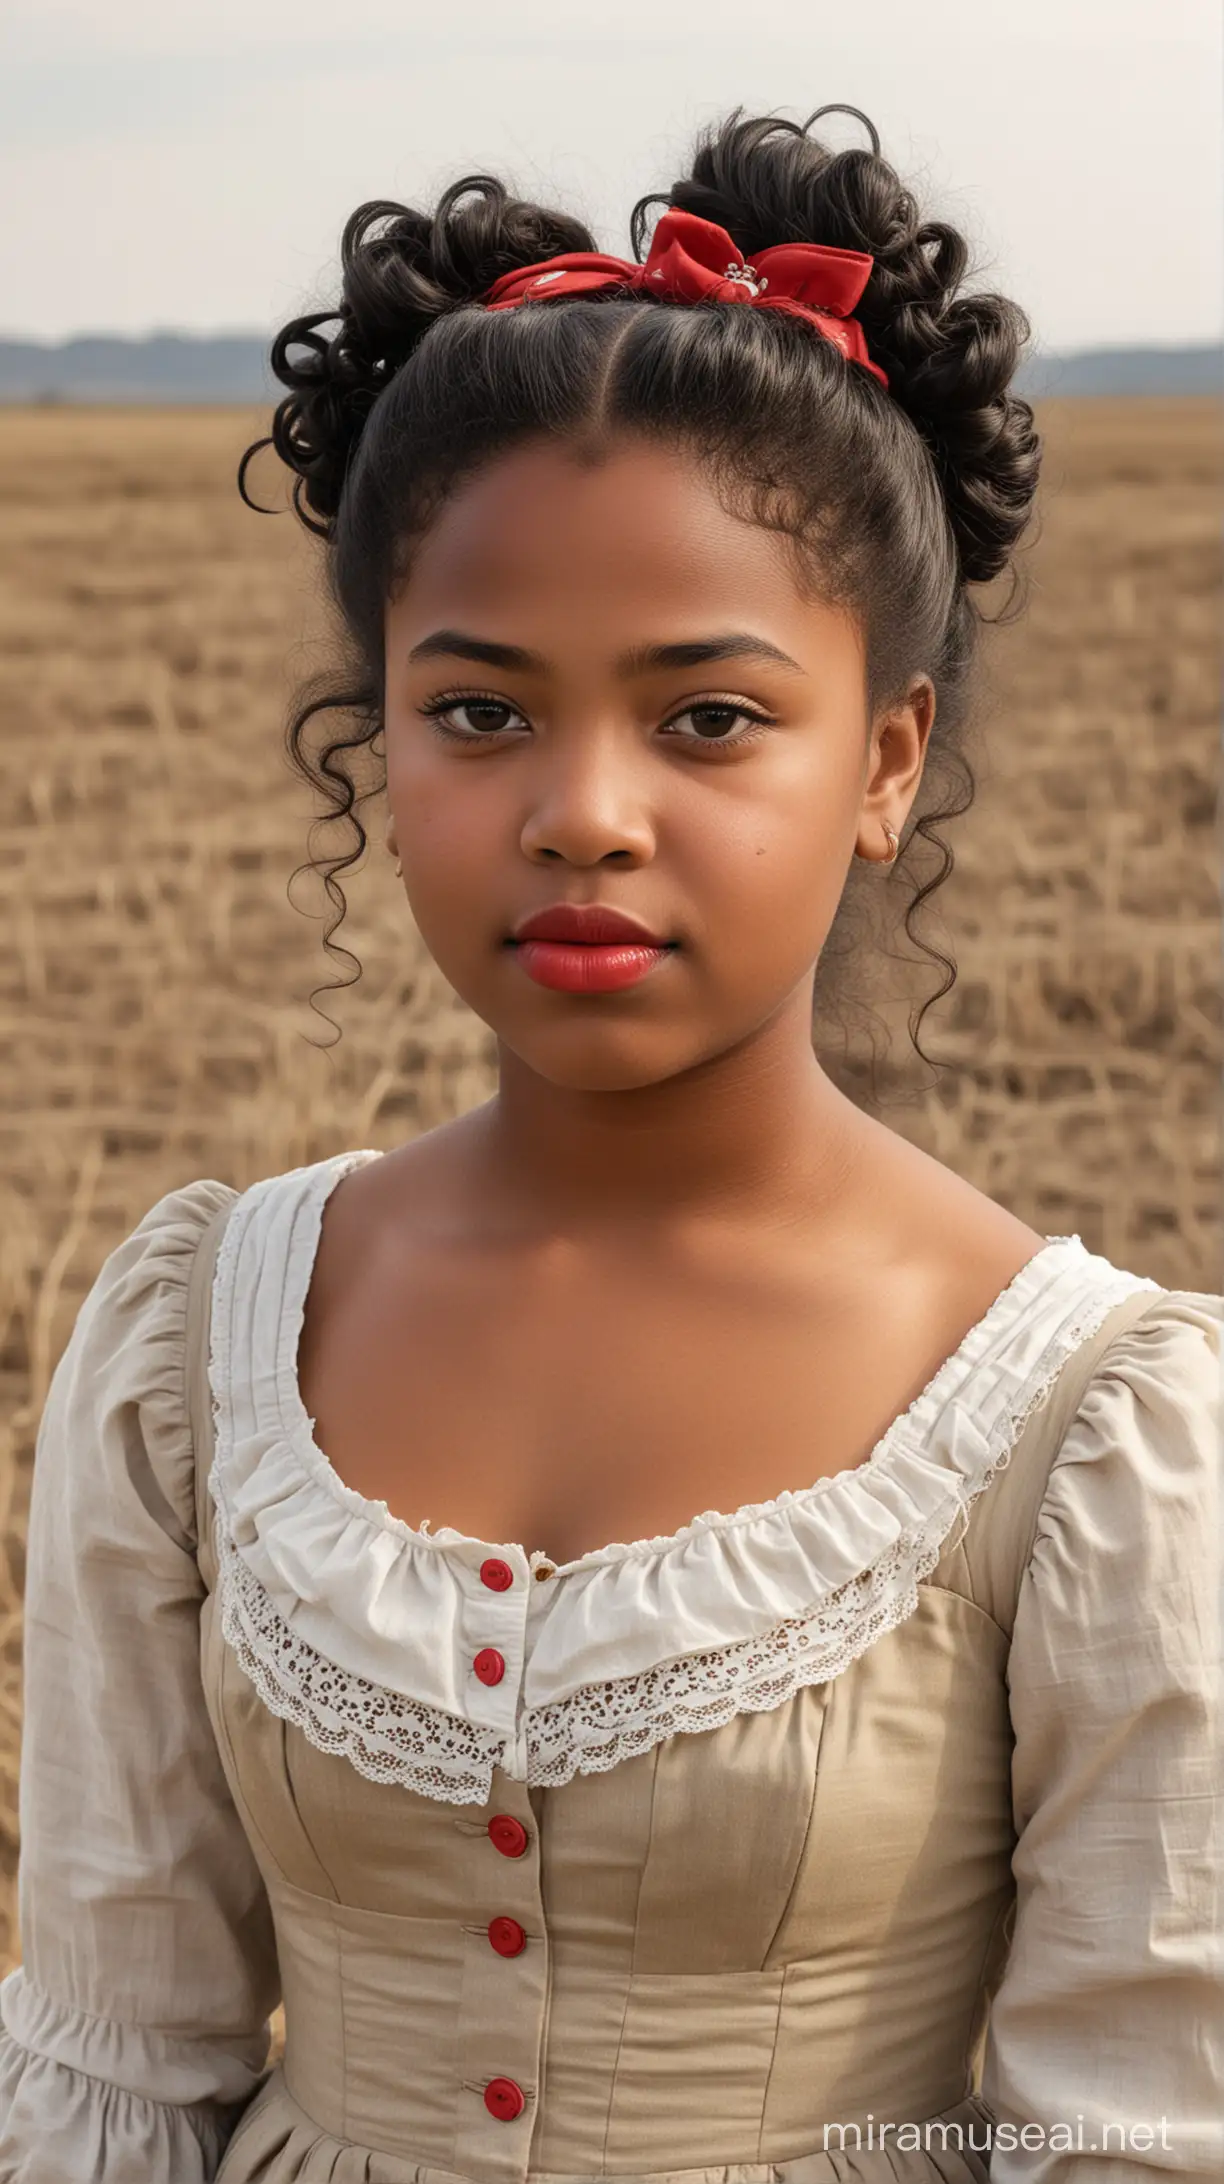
[{"xmin": 0, "ymin": 116, "xmax": 1224, "ymax": 2184}]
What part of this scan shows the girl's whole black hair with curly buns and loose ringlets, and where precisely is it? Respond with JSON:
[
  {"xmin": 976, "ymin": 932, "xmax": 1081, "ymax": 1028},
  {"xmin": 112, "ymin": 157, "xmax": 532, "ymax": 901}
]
[{"xmin": 238, "ymin": 107, "xmax": 1040, "ymax": 1081}]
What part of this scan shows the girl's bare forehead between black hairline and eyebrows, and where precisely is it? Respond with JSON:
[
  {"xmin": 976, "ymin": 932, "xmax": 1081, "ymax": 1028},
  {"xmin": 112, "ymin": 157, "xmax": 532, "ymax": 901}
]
[{"xmin": 389, "ymin": 441, "xmax": 828, "ymax": 629}]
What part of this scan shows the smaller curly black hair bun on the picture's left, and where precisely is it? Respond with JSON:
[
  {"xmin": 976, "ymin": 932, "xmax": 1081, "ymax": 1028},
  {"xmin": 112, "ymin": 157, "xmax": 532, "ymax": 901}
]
[{"xmin": 240, "ymin": 175, "xmax": 595, "ymax": 537}]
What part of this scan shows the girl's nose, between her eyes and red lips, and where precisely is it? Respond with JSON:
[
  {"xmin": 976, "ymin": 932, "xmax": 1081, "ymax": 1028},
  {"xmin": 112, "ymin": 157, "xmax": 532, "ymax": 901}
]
[{"xmin": 520, "ymin": 727, "xmax": 654, "ymax": 865}]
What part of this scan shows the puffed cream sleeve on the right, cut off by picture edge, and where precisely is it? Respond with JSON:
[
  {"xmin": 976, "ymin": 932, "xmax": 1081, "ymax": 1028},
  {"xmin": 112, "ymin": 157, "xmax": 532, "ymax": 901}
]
[{"xmin": 981, "ymin": 1291, "xmax": 1224, "ymax": 2184}]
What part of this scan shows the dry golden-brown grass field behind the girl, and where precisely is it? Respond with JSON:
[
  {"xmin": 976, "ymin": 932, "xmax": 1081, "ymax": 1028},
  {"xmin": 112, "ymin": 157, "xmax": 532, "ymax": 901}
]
[{"xmin": 0, "ymin": 402, "xmax": 1222, "ymax": 2000}]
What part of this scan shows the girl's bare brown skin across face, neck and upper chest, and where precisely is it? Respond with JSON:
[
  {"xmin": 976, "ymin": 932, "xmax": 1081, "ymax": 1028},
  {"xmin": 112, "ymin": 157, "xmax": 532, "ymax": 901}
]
[{"xmin": 299, "ymin": 441, "xmax": 1045, "ymax": 1564}]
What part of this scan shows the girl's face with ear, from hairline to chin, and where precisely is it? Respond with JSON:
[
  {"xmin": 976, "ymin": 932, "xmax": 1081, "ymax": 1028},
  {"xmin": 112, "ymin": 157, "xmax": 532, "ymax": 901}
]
[{"xmin": 385, "ymin": 441, "xmax": 933, "ymax": 1090}]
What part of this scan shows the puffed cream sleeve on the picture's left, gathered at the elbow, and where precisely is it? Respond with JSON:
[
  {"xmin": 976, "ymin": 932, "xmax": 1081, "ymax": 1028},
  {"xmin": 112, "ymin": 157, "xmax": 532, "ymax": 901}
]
[{"xmin": 0, "ymin": 1179, "xmax": 280, "ymax": 2184}]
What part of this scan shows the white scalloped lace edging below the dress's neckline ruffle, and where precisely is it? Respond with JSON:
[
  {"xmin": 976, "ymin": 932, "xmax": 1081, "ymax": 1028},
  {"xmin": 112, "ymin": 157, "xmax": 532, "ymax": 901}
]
[{"xmin": 210, "ymin": 1278, "xmax": 1158, "ymax": 1804}]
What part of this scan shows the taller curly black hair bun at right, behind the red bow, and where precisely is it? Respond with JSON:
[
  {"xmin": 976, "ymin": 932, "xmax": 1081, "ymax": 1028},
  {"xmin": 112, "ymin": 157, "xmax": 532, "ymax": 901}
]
[{"xmin": 634, "ymin": 107, "xmax": 1040, "ymax": 583}]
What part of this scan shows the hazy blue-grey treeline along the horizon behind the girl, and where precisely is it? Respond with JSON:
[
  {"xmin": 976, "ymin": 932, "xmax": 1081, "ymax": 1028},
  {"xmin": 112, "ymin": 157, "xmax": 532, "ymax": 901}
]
[{"xmin": 0, "ymin": 334, "xmax": 1224, "ymax": 404}]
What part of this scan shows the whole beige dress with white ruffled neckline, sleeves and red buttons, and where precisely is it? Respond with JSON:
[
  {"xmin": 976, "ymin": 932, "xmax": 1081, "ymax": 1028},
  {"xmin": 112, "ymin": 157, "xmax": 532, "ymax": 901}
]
[{"xmin": 0, "ymin": 1151, "xmax": 1224, "ymax": 2184}]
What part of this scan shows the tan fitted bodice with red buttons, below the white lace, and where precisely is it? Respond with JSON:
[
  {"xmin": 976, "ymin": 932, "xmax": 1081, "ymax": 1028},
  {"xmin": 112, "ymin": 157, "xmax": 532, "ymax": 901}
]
[{"xmin": 205, "ymin": 1520, "xmax": 1014, "ymax": 2184}]
